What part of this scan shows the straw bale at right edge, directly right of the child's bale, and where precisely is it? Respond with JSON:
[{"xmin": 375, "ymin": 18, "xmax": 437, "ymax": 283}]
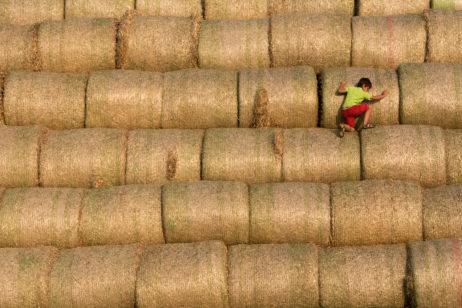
[{"xmin": 399, "ymin": 63, "xmax": 462, "ymax": 128}]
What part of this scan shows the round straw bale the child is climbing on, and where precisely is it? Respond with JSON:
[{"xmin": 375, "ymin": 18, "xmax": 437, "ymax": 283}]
[{"xmin": 321, "ymin": 67, "xmax": 400, "ymax": 128}]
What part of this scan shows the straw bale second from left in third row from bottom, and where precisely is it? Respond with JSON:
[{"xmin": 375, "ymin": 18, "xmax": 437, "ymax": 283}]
[{"xmin": 40, "ymin": 128, "xmax": 127, "ymax": 188}]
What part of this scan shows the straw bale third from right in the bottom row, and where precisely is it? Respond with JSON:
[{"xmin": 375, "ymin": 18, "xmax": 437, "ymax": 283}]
[{"xmin": 228, "ymin": 244, "xmax": 319, "ymax": 307}]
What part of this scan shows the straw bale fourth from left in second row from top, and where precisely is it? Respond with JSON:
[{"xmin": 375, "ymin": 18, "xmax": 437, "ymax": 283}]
[{"xmin": 199, "ymin": 19, "xmax": 270, "ymax": 70}]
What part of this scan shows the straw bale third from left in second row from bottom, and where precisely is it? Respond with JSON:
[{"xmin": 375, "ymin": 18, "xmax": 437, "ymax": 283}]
[{"xmin": 162, "ymin": 181, "xmax": 249, "ymax": 245}]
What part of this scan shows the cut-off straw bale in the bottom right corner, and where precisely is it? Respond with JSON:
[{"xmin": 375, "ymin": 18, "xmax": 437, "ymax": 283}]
[{"xmin": 408, "ymin": 239, "xmax": 462, "ymax": 308}]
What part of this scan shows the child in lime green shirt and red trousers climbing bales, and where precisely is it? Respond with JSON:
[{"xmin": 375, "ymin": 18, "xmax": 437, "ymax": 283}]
[{"xmin": 338, "ymin": 78, "xmax": 388, "ymax": 137}]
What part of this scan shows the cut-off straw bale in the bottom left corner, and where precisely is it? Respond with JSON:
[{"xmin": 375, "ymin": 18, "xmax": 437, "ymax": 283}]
[{"xmin": 0, "ymin": 247, "xmax": 58, "ymax": 308}]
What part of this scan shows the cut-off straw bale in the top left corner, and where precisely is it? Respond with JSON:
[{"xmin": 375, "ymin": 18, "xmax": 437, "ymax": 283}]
[{"xmin": 0, "ymin": 0, "xmax": 64, "ymax": 25}]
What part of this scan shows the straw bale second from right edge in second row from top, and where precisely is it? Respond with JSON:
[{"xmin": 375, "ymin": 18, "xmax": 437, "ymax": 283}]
[{"xmin": 351, "ymin": 14, "xmax": 427, "ymax": 69}]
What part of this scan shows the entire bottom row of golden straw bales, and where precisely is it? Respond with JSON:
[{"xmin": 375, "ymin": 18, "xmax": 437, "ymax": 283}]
[{"xmin": 0, "ymin": 239, "xmax": 462, "ymax": 308}]
